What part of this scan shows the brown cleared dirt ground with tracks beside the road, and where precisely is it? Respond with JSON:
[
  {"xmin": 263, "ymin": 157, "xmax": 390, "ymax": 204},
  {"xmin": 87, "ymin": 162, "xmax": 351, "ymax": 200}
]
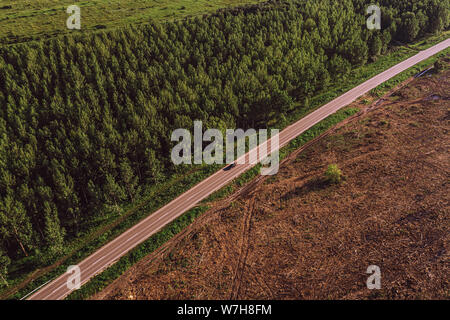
[{"xmin": 94, "ymin": 63, "xmax": 450, "ymax": 299}]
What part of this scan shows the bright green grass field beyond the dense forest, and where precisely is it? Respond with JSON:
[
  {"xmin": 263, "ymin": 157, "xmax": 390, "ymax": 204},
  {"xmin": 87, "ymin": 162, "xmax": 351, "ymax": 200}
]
[{"xmin": 0, "ymin": 0, "xmax": 263, "ymax": 44}]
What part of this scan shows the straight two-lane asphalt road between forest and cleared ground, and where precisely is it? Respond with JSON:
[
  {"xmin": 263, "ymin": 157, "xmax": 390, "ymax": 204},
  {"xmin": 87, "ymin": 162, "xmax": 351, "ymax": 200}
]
[{"xmin": 28, "ymin": 39, "xmax": 450, "ymax": 300}]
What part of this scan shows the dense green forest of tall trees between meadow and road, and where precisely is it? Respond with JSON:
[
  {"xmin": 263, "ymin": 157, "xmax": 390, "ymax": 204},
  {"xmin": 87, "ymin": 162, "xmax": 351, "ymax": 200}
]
[{"xmin": 0, "ymin": 0, "xmax": 449, "ymax": 285}]
